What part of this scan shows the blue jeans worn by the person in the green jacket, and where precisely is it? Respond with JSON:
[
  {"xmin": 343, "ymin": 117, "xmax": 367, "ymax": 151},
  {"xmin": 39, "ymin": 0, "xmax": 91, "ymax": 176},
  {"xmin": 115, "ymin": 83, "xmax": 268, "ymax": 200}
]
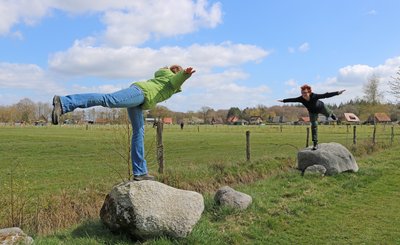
[{"xmin": 60, "ymin": 85, "xmax": 147, "ymax": 176}]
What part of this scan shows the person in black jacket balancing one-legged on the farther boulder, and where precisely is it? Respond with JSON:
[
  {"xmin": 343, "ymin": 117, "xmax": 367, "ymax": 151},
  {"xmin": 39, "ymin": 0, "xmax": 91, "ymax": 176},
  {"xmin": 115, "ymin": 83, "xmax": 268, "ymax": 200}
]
[{"xmin": 278, "ymin": 84, "xmax": 345, "ymax": 150}]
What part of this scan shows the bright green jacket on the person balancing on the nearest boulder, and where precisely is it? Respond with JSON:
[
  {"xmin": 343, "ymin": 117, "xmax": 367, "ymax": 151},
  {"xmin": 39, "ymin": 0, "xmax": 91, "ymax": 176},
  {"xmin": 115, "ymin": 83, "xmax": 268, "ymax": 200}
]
[{"xmin": 133, "ymin": 68, "xmax": 190, "ymax": 110}]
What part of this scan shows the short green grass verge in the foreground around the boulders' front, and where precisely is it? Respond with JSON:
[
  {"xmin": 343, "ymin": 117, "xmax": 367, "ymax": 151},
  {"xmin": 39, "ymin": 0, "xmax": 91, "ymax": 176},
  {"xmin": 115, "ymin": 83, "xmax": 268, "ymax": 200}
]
[{"xmin": 32, "ymin": 147, "xmax": 400, "ymax": 244}]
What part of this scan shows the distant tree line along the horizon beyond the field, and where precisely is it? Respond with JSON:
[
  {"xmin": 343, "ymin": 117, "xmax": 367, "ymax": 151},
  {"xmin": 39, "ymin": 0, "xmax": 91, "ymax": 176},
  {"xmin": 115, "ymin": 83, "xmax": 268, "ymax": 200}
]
[{"xmin": 0, "ymin": 69, "xmax": 400, "ymax": 124}]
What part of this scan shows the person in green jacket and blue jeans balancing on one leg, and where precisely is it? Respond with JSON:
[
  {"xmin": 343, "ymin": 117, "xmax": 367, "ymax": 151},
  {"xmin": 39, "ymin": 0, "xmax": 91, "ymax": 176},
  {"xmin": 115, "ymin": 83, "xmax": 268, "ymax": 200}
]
[{"xmin": 52, "ymin": 65, "xmax": 195, "ymax": 181}]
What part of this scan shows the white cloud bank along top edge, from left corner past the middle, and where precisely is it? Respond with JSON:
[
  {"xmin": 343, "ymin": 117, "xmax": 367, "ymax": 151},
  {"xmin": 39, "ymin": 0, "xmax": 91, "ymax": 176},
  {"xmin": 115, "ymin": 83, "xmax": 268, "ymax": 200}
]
[{"xmin": 0, "ymin": 0, "xmax": 222, "ymax": 47}]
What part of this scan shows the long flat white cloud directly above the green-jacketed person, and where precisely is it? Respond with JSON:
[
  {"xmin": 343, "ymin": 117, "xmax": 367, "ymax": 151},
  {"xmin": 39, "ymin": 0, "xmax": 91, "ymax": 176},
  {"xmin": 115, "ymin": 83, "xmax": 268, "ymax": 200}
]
[{"xmin": 49, "ymin": 42, "xmax": 269, "ymax": 79}]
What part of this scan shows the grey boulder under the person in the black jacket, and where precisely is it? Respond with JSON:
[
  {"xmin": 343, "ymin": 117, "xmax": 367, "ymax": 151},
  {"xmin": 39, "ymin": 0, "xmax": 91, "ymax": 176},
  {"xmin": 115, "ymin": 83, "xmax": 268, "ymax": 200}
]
[{"xmin": 297, "ymin": 142, "xmax": 358, "ymax": 175}]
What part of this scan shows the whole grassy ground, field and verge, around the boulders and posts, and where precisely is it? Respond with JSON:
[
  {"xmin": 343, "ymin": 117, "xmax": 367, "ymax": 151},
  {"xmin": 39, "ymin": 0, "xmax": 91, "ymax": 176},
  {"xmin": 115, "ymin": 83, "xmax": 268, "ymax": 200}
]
[{"xmin": 0, "ymin": 125, "xmax": 400, "ymax": 244}]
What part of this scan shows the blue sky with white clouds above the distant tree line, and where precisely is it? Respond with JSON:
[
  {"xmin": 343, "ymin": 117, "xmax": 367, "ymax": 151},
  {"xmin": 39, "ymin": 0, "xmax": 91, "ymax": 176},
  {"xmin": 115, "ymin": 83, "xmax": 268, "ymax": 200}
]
[{"xmin": 0, "ymin": 0, "xmax": 400, "ymax": 111}]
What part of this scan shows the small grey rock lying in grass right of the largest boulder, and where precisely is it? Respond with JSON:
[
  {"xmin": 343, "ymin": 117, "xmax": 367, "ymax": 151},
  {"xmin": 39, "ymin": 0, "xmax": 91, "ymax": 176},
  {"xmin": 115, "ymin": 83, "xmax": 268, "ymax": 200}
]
[{"xmin": 214, "ymin": 186, "xmax": 253, "ymax": 210}]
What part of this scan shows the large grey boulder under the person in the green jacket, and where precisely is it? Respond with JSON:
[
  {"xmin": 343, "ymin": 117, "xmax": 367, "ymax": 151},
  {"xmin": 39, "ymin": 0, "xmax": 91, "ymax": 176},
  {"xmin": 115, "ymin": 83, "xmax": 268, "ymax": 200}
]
[{"xmin": 100, "ymin": 180, "xmax": 204, "ymax": 239}]
